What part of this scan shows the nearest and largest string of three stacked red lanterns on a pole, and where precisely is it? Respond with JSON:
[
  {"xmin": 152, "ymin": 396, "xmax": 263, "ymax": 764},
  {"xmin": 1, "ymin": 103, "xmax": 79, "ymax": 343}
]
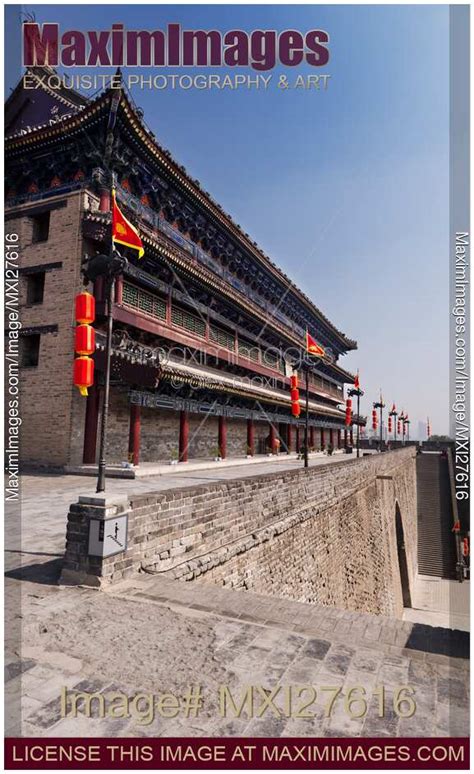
[{"xmin": 74, "ymin": 291, "xmax": 95, "ymax": 396}]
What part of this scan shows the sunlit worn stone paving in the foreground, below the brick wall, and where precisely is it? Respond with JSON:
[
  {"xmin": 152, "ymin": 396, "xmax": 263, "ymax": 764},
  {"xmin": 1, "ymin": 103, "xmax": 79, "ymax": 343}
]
[{"xmin": 6, "ymin": 576, "xmax": 469, "ymax": 737}]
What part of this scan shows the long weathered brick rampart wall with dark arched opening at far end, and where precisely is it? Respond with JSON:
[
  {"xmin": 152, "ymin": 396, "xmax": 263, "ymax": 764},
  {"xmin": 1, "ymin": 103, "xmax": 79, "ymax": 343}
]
[{"xmin": 63, "ymin": 448, "xmax": 417, "ymax": 615}]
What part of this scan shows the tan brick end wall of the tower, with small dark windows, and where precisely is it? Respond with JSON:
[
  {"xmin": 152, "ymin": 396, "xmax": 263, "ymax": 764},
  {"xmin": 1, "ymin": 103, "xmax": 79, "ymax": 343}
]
[{"xmin": 6, "ymin": 193, "xmax": 89, "ymax": 466}]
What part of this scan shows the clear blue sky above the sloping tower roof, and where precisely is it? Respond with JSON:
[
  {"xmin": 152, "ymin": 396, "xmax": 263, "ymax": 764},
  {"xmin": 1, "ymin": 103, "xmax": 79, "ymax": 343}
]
[{"xmin": 6, "ymin": 5, "xmax": 449, "ymax": 433}]
